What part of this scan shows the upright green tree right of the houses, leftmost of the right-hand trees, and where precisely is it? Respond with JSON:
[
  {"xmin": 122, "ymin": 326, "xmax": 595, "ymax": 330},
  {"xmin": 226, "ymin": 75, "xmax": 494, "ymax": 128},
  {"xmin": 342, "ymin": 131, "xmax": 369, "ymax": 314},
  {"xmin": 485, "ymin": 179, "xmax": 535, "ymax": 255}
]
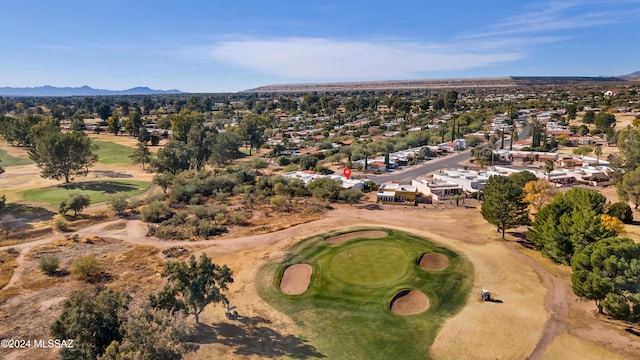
[{"xmin": 480, "ymin": 175, "xmax": 529, "ymax": 239}]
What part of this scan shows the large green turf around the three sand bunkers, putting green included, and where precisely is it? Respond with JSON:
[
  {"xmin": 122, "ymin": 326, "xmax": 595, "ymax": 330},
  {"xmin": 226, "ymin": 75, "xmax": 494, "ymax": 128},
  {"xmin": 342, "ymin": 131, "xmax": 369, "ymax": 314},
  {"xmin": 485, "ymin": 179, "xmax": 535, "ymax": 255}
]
[{"xmin": 256, "ymin": 229, "xmax": 473, "ymax": 359}]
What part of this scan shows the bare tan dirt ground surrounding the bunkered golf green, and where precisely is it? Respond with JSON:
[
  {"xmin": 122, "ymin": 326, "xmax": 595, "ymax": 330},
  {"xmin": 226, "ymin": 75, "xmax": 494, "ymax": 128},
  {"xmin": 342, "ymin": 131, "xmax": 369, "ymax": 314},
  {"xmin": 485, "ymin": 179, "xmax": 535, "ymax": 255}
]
[{"xmin": 0, "ymin": 200, "xmax": 640, "ymax": 360}]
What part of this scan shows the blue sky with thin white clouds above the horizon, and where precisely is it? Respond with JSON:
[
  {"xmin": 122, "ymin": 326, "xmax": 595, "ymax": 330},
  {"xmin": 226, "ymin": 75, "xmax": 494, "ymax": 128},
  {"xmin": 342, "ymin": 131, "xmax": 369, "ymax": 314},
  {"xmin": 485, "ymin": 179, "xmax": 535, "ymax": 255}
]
[{"xmin": 0, "ymin": 0, "xmax": 640, "ymax": 92}]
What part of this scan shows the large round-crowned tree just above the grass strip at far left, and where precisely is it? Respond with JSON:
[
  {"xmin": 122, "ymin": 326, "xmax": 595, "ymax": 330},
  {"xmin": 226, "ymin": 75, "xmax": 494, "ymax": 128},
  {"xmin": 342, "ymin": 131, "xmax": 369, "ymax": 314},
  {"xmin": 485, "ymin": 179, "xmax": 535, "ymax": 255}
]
[{"xmin": 29, "ymin": 132, "xmax": 98, "ymax": 183}]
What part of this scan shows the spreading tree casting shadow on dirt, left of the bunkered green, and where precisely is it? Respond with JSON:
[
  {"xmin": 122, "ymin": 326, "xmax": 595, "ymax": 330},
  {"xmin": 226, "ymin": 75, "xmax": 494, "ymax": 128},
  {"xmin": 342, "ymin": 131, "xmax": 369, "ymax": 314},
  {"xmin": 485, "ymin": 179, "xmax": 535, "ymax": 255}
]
[{"xmin": 162, "ymin": 253, "xmax": 233, "ymax": 323}]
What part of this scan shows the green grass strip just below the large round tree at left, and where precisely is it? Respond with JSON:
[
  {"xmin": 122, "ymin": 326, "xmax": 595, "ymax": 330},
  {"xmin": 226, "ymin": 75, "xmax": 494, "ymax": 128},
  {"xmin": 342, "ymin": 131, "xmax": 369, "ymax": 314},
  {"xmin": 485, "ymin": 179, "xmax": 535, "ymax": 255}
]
[{"xmin": 22, "ymin": 180, "xmax": 151, "ymax": 208}]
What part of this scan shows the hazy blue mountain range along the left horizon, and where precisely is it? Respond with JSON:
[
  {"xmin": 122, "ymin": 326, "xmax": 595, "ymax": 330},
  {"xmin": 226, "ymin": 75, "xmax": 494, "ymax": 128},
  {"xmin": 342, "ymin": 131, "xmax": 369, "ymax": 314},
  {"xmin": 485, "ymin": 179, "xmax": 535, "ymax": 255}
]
[{"xmin": 0, "ymin": 85, "xmax": 184, "ymax": 96}]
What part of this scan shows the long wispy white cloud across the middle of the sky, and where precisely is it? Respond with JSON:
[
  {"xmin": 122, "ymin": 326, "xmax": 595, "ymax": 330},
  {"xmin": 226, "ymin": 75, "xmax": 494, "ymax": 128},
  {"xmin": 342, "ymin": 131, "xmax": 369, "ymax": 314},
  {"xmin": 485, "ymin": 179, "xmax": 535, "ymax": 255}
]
[{"xmin": 208, "ymin": 37, "xmax": 522, "ymax": 80}]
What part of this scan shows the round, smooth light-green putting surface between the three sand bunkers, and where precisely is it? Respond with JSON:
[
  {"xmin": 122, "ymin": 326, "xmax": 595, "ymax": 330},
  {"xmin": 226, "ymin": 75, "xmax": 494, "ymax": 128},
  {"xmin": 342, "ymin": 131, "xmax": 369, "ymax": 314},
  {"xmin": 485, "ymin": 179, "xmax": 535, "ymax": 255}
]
[{"xmin": 328, "ymin": 240, "xmax": 404, "ymax": 286}]
